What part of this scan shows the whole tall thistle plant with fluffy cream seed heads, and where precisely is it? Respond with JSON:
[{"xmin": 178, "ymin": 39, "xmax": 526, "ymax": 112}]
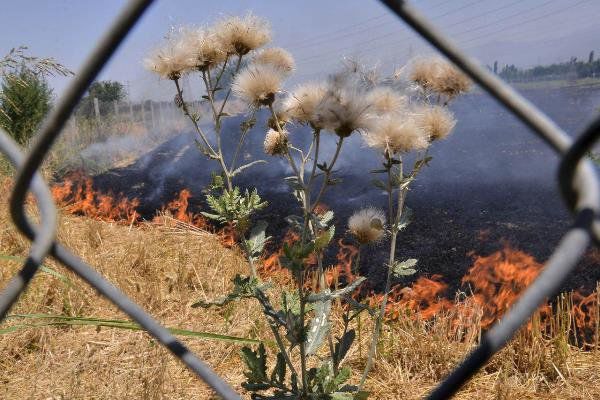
[{"xmin": 146, "ymin": 14, "xmax": 469, "ymax": 399}]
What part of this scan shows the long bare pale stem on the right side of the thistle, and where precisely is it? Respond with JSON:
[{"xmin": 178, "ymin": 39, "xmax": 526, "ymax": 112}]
[{"xmin": 358, "ymin": 156, "xmax": 407, "ymax": 391}]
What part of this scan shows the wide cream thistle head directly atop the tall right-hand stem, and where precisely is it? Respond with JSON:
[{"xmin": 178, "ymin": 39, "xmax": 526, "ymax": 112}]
[{"xmin": 364, "ymin": 114, "xmax": 429, "ymax": 155}]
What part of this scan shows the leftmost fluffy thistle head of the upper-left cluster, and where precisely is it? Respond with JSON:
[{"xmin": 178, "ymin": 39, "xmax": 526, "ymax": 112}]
[{"xmin": 144, "ymin": 38, "xmax": 195, "ymax": 80}]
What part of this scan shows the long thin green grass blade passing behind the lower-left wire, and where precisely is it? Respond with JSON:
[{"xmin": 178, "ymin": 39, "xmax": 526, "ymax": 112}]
[{"xmin": 0, "ymin": 314, "xmax": 260, "ymax": 344}]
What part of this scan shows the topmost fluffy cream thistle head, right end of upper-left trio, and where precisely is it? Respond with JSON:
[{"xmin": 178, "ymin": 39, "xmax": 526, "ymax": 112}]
[{"xmin": 214, "ymin": 13, "xmax": 271, "ymax": 56}]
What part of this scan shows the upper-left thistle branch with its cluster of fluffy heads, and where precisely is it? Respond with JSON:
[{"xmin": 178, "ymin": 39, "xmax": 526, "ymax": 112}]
[{"xmin": 144, "ymin": 14, "xmax": 278, "ymax": 242}]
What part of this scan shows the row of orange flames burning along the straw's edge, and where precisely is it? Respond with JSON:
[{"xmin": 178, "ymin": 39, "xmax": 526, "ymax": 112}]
[{"xmin": 52, "ymin": 174, "xmax": 600, "ymax": 343}]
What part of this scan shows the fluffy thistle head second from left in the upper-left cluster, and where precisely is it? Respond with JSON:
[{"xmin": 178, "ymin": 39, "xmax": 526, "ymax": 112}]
[{"xmin": 182, "ymin": 28, "xmax": 227, "ymax": 71}]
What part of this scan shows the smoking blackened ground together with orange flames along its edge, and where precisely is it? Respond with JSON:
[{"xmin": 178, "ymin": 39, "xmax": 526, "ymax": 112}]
[{"xmin": 48, "ymin": 83, "xmax": 600, "ymax": 328}]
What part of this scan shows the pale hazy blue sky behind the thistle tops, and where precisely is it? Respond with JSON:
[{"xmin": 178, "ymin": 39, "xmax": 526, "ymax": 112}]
[{"xmin": 0, "ymin": 0, "xmax": 600, "ymax": 99}]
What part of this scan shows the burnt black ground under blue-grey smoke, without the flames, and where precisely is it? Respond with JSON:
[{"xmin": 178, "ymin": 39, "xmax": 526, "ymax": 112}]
[{"xmin": 88, "ymin": 88, "xmax": 600, "ymax": 289}]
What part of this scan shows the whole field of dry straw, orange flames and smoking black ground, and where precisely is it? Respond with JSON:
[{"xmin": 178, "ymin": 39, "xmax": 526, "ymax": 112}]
[{"xmin": 0, "ymin": 66, "xmax": 600, "ymax": 399}]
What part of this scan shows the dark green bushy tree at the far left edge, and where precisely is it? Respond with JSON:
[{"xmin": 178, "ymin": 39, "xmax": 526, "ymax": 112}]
[{"xmin": 0, "ymin": 67, "xmax": 52, "ymax": 145}]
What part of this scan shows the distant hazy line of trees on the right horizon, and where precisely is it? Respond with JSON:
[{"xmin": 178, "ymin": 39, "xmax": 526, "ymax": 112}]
[{"xmin": 488, "ymin": 51, "xmax": 600, "ymax": 82}]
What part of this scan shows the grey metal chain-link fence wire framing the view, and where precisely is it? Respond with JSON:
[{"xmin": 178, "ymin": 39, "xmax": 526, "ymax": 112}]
[{"xmin": 0, "ymin": 0, "xmax": 600, "ymax": 400}]
